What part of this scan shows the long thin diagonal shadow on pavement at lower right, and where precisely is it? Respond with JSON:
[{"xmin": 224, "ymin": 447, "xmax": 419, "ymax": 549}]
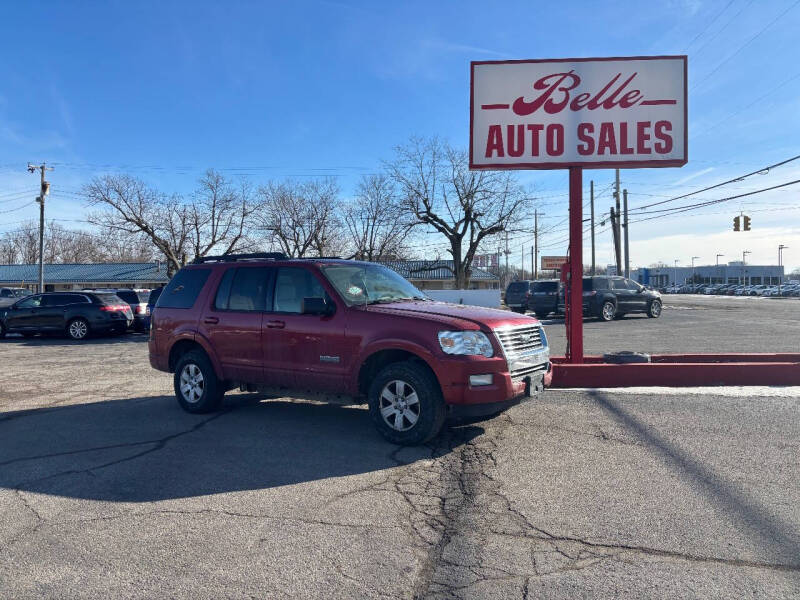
[{"xmin": 588, "ymin": 391, "xmax": 800, "ymax": 570}]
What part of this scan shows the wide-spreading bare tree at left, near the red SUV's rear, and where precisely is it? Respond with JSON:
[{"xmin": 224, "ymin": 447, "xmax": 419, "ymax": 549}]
[{"xmin": 84, "ymin": 170, "xmax": 256, "ymax": 273}]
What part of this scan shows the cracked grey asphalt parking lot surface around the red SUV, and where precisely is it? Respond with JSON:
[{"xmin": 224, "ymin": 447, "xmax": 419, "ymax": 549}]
[{"xmin": 0, "ymin": 297, "xmax": 800, "ymax": 598}]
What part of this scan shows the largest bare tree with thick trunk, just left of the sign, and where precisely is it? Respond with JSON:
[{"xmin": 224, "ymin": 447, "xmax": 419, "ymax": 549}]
[{"xmin": 386, "ymin": 138, "xmax": 528, "ymax": 289}]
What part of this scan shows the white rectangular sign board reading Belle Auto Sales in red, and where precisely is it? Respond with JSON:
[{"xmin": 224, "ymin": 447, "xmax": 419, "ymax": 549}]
[{"xmin": 469, "ymin": 56, "xmax": 688, "ymax": 169}]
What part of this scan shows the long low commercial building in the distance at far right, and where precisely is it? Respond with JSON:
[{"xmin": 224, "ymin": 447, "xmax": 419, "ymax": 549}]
[{"xmin": 631, "ymin": 261, "xmax": 784, "ymax": 288}]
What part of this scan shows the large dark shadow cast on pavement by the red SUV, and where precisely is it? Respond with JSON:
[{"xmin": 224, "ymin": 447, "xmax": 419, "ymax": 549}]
[{"xmin": 0, "ymin": 394, "xmax": 484, "ymax": 502}]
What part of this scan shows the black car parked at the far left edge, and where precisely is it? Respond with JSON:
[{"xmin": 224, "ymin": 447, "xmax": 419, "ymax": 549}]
[{"xmin": 0, "ymin": 292, "xmax": 133, "ymax": 340}]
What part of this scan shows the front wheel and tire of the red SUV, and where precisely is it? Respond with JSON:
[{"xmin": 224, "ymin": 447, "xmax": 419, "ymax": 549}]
[{"xmin": 367, "ymin": 361, "xmax": 446, "ymax": 446}]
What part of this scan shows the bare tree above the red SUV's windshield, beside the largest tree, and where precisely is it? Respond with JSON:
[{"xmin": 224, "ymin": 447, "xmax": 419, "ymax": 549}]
[{"xmin": 344, "ymin": 174, "xmax": 412, "ymax": 261}]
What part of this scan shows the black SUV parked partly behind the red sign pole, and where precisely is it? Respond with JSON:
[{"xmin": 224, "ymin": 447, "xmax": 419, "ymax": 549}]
[{"xmin": 559, "ymin": 276, "xmax": 662, "ymax": 321}]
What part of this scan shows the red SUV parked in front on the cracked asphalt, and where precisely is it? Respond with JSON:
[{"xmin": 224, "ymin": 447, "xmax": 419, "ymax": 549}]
[{"xmin": 149, "ymin": 253, "xmax": 550, "ymax": 444}]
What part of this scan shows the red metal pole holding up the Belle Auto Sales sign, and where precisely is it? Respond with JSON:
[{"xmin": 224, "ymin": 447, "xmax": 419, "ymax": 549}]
[{"xmin": 565, "ymin": 167, "xmax": 583, "ymax": 364}]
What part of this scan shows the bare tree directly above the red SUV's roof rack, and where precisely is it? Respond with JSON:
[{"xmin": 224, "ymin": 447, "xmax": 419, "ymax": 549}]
[{"xmin": 256, "ymin": 179, "xmax": 344, "ymax": 258}]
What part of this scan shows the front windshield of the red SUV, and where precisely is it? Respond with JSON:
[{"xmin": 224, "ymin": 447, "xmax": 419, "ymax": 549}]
[{"xmin": 322, "ymin": 265, "xmax": 429, "ymax": 306}]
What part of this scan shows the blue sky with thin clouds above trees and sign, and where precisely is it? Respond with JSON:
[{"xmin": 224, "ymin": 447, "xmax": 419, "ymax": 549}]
[{"xmin": 0, "ymin": 0, "xmax": 800, "ymax": 268}]
